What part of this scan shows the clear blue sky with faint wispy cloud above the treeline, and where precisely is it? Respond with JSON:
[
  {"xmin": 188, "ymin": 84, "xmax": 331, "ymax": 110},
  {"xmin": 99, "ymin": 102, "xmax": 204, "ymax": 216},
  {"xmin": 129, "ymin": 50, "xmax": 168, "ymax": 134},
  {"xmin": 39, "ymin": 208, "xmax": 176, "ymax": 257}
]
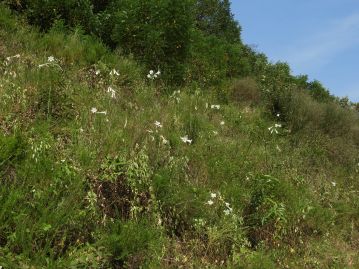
[{"xmin": 232, "ymin": 0, "xmax": 359, "ymax": 102}]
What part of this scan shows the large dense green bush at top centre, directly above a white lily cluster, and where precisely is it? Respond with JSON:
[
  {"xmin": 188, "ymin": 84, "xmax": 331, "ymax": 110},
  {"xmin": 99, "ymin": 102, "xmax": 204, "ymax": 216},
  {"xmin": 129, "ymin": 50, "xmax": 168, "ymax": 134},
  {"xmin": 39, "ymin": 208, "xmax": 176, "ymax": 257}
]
[{"xmin": 110, "ymin": 0, "xmax": 193, "ymax": 82}]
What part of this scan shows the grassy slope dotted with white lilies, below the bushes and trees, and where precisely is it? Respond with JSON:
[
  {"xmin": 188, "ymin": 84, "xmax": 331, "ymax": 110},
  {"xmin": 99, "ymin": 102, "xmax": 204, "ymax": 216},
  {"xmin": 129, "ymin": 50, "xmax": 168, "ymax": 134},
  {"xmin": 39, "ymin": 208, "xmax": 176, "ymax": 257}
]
[{"xmin": 0, "ymin": 7, "xmax": 359, "ymax": 268}]
